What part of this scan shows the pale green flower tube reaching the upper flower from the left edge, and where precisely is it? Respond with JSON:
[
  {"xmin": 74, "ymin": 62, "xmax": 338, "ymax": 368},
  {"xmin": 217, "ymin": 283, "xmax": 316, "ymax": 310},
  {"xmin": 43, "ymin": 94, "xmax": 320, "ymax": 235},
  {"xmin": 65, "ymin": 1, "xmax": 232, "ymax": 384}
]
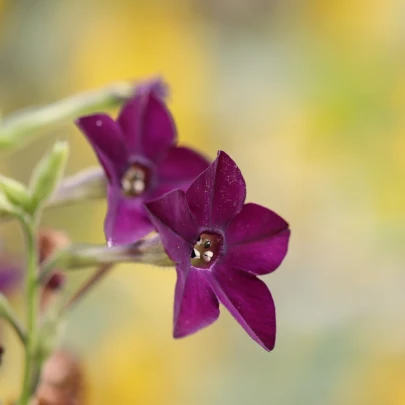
[{"xmin": 0, "ymin": 82, "xmax": 135, "ymax": 150}]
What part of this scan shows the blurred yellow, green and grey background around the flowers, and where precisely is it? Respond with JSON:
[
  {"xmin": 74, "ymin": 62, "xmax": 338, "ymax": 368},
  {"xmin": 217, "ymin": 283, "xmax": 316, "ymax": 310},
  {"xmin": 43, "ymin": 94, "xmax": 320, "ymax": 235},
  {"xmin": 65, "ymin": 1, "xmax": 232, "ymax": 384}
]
[{"xmin": 0, "ymin": 0, "xmax": 405, "ymax": 405}]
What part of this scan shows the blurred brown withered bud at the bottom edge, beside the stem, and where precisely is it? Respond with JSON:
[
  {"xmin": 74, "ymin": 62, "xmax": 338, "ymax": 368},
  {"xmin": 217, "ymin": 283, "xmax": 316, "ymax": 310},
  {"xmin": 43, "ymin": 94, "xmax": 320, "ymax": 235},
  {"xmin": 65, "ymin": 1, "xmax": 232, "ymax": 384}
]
[{"xmin": 35, "ymin": 351, "xmax": 84, "ymax": 405}]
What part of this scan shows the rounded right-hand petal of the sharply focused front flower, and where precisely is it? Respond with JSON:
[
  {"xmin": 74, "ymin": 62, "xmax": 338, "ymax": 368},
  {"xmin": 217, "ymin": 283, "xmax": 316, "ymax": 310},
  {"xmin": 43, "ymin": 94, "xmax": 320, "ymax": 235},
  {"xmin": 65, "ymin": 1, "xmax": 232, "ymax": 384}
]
[{"xmin": 225, "ymin": 203, "xmax": 290, "ymax": 274}]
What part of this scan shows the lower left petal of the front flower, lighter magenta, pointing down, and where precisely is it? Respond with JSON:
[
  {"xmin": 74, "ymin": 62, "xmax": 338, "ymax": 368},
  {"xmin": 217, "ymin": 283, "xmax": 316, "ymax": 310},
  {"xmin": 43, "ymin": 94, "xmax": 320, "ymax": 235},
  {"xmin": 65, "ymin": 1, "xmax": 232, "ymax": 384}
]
[{"xmin": 173, "ymin": 265, "xmax": 219, "ymax": 338}]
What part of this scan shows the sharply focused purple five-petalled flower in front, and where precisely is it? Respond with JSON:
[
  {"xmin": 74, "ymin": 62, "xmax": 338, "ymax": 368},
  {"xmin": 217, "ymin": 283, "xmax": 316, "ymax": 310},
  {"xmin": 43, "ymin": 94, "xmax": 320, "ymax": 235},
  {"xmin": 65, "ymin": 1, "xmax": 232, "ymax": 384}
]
[{"xmin": 146, "ymin": 152, "xmax": 290, "ymax": 350}]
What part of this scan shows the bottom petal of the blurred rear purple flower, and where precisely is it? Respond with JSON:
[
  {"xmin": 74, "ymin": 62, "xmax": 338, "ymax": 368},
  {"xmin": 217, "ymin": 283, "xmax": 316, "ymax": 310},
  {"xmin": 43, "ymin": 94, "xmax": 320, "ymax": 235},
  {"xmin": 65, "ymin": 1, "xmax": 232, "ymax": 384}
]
[{"xmin": 104, "ymin": 186, "xmax": 154, "ymax": 245}]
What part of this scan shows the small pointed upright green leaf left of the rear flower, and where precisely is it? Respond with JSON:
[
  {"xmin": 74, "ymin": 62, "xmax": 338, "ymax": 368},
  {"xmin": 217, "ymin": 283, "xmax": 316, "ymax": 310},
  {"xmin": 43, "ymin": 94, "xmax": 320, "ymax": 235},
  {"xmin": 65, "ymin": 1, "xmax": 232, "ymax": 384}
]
[{"xmin": 30, "ymin": 142, "xmax": 69, "ymax": 212}]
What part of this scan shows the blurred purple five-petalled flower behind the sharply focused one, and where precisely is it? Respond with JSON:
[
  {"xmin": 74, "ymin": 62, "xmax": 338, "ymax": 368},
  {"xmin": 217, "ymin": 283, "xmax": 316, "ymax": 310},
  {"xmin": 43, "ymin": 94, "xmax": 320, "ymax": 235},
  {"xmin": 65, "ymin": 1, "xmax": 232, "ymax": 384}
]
[{"xmin": 77, "ymin": 81, "xmax": 208, "ymax": 245}]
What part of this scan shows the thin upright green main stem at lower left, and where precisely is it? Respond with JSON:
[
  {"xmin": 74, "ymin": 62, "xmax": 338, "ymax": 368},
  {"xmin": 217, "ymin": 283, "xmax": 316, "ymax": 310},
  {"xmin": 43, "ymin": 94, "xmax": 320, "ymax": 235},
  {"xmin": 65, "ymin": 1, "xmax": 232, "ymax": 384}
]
[{"xmin": 19, "ymin": 218, "xmax": 39, "ymax": 405}]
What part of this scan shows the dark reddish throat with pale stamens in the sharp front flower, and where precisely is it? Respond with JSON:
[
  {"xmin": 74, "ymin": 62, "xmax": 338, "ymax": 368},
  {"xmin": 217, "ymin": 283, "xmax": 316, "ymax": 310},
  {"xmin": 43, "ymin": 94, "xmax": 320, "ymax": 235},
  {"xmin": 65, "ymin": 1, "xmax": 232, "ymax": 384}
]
[{"xmin": 191, "ymin": 232, "xmax": 222, "ymax": 269}]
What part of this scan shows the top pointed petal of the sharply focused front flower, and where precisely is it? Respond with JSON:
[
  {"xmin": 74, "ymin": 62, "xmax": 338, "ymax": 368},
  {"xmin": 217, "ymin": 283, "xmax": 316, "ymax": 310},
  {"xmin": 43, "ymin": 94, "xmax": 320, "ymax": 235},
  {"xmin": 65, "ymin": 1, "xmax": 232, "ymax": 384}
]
[{"xmin": 187, "ymin": 151, "xmax": 246, "ymax": 229}]
